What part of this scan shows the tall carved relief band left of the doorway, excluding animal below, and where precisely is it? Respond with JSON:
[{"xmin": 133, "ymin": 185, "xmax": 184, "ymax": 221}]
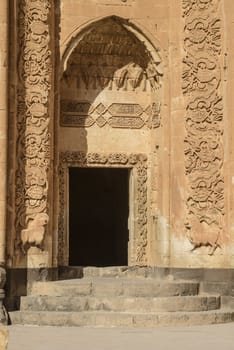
[{"xmin": 16, "ymin": 0, "xmax": 52, "ymax": 249}]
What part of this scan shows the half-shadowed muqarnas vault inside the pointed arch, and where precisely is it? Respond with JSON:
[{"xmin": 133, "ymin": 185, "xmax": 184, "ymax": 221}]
[{"xmin": 63, "ymin": 17, "xmax": 162, "ymax": 91}]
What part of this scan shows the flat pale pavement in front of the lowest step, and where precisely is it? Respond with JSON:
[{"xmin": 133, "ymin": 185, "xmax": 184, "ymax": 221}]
[{"xmin": 8, "ymin": 323, "xmax": 234, "ymax": 350}]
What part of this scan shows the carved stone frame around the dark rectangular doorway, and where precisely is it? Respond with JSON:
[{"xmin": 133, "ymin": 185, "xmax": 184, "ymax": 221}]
[{"xmin": 58, "ymin": 151, "xmax": 148, "ymax": 266}]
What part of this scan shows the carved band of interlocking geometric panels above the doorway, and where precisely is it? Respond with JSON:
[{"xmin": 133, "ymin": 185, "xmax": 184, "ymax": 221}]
[{"xmin": 60, "ymin": 100, "xmax": 160, "ymax": 129}]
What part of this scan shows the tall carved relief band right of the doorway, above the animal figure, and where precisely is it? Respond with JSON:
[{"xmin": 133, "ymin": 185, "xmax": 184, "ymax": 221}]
[{"xmin": 182, "ymin": 0, "xmax": 224, "ymax": 255}]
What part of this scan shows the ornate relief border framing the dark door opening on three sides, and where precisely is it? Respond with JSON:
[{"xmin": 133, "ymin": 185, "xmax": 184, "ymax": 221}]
[{"xmin": 58, "ymin": 151, "xmax": 148, "ymax": 266}]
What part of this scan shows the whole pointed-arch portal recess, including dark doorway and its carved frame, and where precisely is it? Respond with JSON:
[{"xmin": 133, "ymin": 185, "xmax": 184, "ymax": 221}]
[{"xmin": 58, "ymin": 16, "xmax": 162, "ymax": 266}]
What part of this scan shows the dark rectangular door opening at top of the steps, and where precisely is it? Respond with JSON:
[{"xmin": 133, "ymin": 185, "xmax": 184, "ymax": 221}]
[{"xmin": 69, "ymin": 168, "xmax": 129, "ymax": 266}]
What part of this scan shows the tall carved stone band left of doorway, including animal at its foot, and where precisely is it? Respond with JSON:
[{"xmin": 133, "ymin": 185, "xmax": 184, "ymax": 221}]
[{"xmin": 15, "ymin": 0, "xmax": 53, "ymax": 268}]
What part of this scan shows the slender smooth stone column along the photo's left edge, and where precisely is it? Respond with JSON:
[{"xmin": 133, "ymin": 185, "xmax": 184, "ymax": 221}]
[{"xmin": 0, "ymin": 0, "xmax": 8, "ymax": 323}]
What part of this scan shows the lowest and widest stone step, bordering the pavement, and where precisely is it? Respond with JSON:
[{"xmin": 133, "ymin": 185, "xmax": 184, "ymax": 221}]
[{"xmin": 10, "ymin": 310, "xmax": 234, "ymax": 327}]
